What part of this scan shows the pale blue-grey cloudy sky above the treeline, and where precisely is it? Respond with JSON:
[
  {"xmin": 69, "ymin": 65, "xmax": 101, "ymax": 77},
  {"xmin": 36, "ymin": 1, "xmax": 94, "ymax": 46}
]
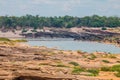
[{"xmin": 0, "ymin": 0, "xmax": 120, "ymax": 17}]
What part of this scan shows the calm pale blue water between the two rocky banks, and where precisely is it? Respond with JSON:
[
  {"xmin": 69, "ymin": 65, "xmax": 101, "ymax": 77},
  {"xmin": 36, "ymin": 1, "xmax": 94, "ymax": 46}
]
[{"xmin": 28, "ymin": 40, "xmax": 120, "ymax": 53}]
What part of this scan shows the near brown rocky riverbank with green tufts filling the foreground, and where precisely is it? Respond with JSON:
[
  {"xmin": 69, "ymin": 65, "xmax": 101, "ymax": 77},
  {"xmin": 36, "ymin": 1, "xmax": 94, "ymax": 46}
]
[{"xmin": 0, "ymin": 43, "xmax": 120, "ymax": 80}]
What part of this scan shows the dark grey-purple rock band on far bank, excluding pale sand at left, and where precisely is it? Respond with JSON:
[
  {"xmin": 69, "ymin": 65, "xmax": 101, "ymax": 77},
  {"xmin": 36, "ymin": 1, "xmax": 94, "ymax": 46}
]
[{"xmin": 22, "ymin": 29, "xmax": 120, "ymax": 45}]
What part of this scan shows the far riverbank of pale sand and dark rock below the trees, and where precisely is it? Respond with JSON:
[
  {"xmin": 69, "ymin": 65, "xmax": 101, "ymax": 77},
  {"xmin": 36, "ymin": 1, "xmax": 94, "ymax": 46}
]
[{"xmin": 0, "ymin": 27, "xmax": 120, "ymax": 46}]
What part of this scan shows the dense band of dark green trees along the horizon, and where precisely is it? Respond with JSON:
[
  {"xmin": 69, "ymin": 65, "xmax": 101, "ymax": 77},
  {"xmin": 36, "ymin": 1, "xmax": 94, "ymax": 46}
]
[{"xmin": 0, "ymin": 15, "xmax": 120, "ymax": 29}]
